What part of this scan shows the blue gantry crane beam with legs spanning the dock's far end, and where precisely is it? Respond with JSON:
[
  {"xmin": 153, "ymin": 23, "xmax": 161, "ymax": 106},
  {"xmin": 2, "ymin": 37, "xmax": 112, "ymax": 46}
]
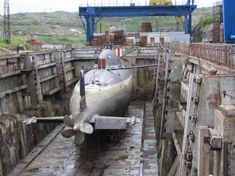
[{"xmin": 79, "ymin": 4, "xmax": 196, "ymax": 42}]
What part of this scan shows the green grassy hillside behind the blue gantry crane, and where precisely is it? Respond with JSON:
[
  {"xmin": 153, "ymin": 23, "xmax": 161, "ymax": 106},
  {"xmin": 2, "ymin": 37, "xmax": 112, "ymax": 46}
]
[{"xmin": 0, "ymin": 8, "xmax": 212, "ymax": 46}]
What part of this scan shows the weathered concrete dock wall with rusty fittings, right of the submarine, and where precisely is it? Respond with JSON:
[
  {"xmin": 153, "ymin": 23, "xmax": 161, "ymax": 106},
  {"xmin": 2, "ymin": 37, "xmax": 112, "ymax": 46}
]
[{"xmin": 154, "ymin": 43, "xmax": 235, "ymax": 176}]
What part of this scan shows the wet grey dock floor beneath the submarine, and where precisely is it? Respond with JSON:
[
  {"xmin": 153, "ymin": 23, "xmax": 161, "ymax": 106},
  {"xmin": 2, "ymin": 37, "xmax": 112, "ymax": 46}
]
[{"xmin": 10, "ymin": 101, "xmax": 158, "ymax": 176}]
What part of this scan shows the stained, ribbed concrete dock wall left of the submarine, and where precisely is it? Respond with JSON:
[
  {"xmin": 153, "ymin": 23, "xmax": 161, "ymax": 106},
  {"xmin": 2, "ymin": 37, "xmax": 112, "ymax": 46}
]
[{"xmin": 0, "ymin": 49, "xmax": 100, "ymax": 176}]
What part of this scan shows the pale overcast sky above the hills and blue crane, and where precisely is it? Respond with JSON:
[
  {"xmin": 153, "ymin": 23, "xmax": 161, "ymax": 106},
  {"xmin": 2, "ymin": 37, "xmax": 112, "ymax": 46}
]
[{"xmin": 0, "ymin": 0, "xmax": 218, "ymax": 14}]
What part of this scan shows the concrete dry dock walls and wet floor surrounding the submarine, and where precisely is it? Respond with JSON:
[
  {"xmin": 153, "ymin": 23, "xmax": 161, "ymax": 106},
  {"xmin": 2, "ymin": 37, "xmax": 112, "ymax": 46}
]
[{"xmin": 0, "ymin": 43, "xmax": 235, "ymax": 176}]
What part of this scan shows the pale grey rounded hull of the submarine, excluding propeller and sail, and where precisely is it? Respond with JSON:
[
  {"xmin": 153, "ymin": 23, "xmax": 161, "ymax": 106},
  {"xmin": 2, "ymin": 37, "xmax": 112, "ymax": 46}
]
[{"xmin": 70, "ymin": 70, "xmax": 132, "ymax": 123}]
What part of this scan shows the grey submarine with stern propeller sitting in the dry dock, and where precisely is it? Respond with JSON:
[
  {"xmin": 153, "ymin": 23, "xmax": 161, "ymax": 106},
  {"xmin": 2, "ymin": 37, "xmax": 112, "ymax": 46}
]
[{"xmin": 62, "ymin": 48, "xmax": 133, "ymax": 144}]
